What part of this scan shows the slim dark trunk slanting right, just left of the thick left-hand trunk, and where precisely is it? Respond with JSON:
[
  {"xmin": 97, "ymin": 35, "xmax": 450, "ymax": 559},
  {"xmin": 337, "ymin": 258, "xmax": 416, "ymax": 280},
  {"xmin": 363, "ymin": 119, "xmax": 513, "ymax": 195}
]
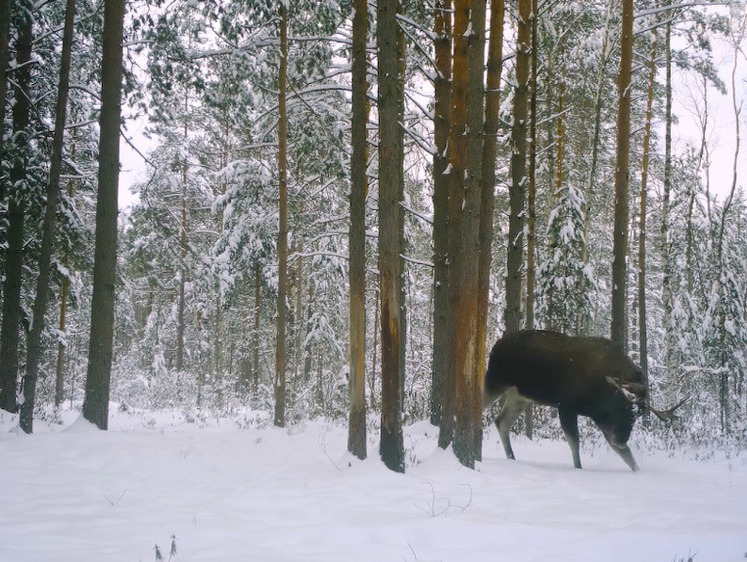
[{"xmin": 20, "ymin": 0, "xmax": 75, "ymax": 433}]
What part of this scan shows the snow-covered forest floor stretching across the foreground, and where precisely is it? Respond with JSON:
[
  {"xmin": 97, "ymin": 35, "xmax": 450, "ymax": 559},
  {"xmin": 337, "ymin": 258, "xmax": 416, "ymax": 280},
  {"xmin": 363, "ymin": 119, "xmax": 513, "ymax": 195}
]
[{"xmin": 0, "ymin": 410, "xmax": 747, "ymax": 562}]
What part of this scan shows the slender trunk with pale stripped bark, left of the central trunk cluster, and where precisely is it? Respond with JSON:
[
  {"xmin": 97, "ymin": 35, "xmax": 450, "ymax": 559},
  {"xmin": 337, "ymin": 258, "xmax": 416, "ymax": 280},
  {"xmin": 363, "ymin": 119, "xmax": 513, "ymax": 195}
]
[{"xmin": 348, "ymin": 0, "xmax": 368, "ymax": 459}]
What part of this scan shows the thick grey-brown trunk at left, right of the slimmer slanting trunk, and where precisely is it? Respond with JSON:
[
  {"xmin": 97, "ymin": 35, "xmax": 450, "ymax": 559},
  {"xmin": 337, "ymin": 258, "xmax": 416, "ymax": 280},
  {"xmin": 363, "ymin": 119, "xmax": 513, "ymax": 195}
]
[{"xmin": 83, "ymin": 0, "xmax": 125, "ymax": 429}]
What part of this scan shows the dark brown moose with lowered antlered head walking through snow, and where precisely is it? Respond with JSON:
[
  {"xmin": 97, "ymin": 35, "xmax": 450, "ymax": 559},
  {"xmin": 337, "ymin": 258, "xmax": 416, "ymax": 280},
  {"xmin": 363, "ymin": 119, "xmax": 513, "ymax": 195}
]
[{"xmin": 484, "ymin": 330, "xmax": 684, "ymax": 471}]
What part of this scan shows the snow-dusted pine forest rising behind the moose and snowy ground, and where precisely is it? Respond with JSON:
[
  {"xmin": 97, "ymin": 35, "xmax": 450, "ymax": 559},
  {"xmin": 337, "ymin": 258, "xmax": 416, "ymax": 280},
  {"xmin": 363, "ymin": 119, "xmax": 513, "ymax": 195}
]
[{"xmin": 0, "ymin": 0, "xmax": 747, "ymax": 470}]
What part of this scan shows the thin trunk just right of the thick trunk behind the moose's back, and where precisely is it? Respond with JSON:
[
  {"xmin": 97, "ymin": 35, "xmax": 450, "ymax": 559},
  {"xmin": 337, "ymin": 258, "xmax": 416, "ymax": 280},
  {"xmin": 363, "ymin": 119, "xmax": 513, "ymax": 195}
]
[{"xmin": 638, "ymin": 31, "xmax": 657, "ymax": 423}]
